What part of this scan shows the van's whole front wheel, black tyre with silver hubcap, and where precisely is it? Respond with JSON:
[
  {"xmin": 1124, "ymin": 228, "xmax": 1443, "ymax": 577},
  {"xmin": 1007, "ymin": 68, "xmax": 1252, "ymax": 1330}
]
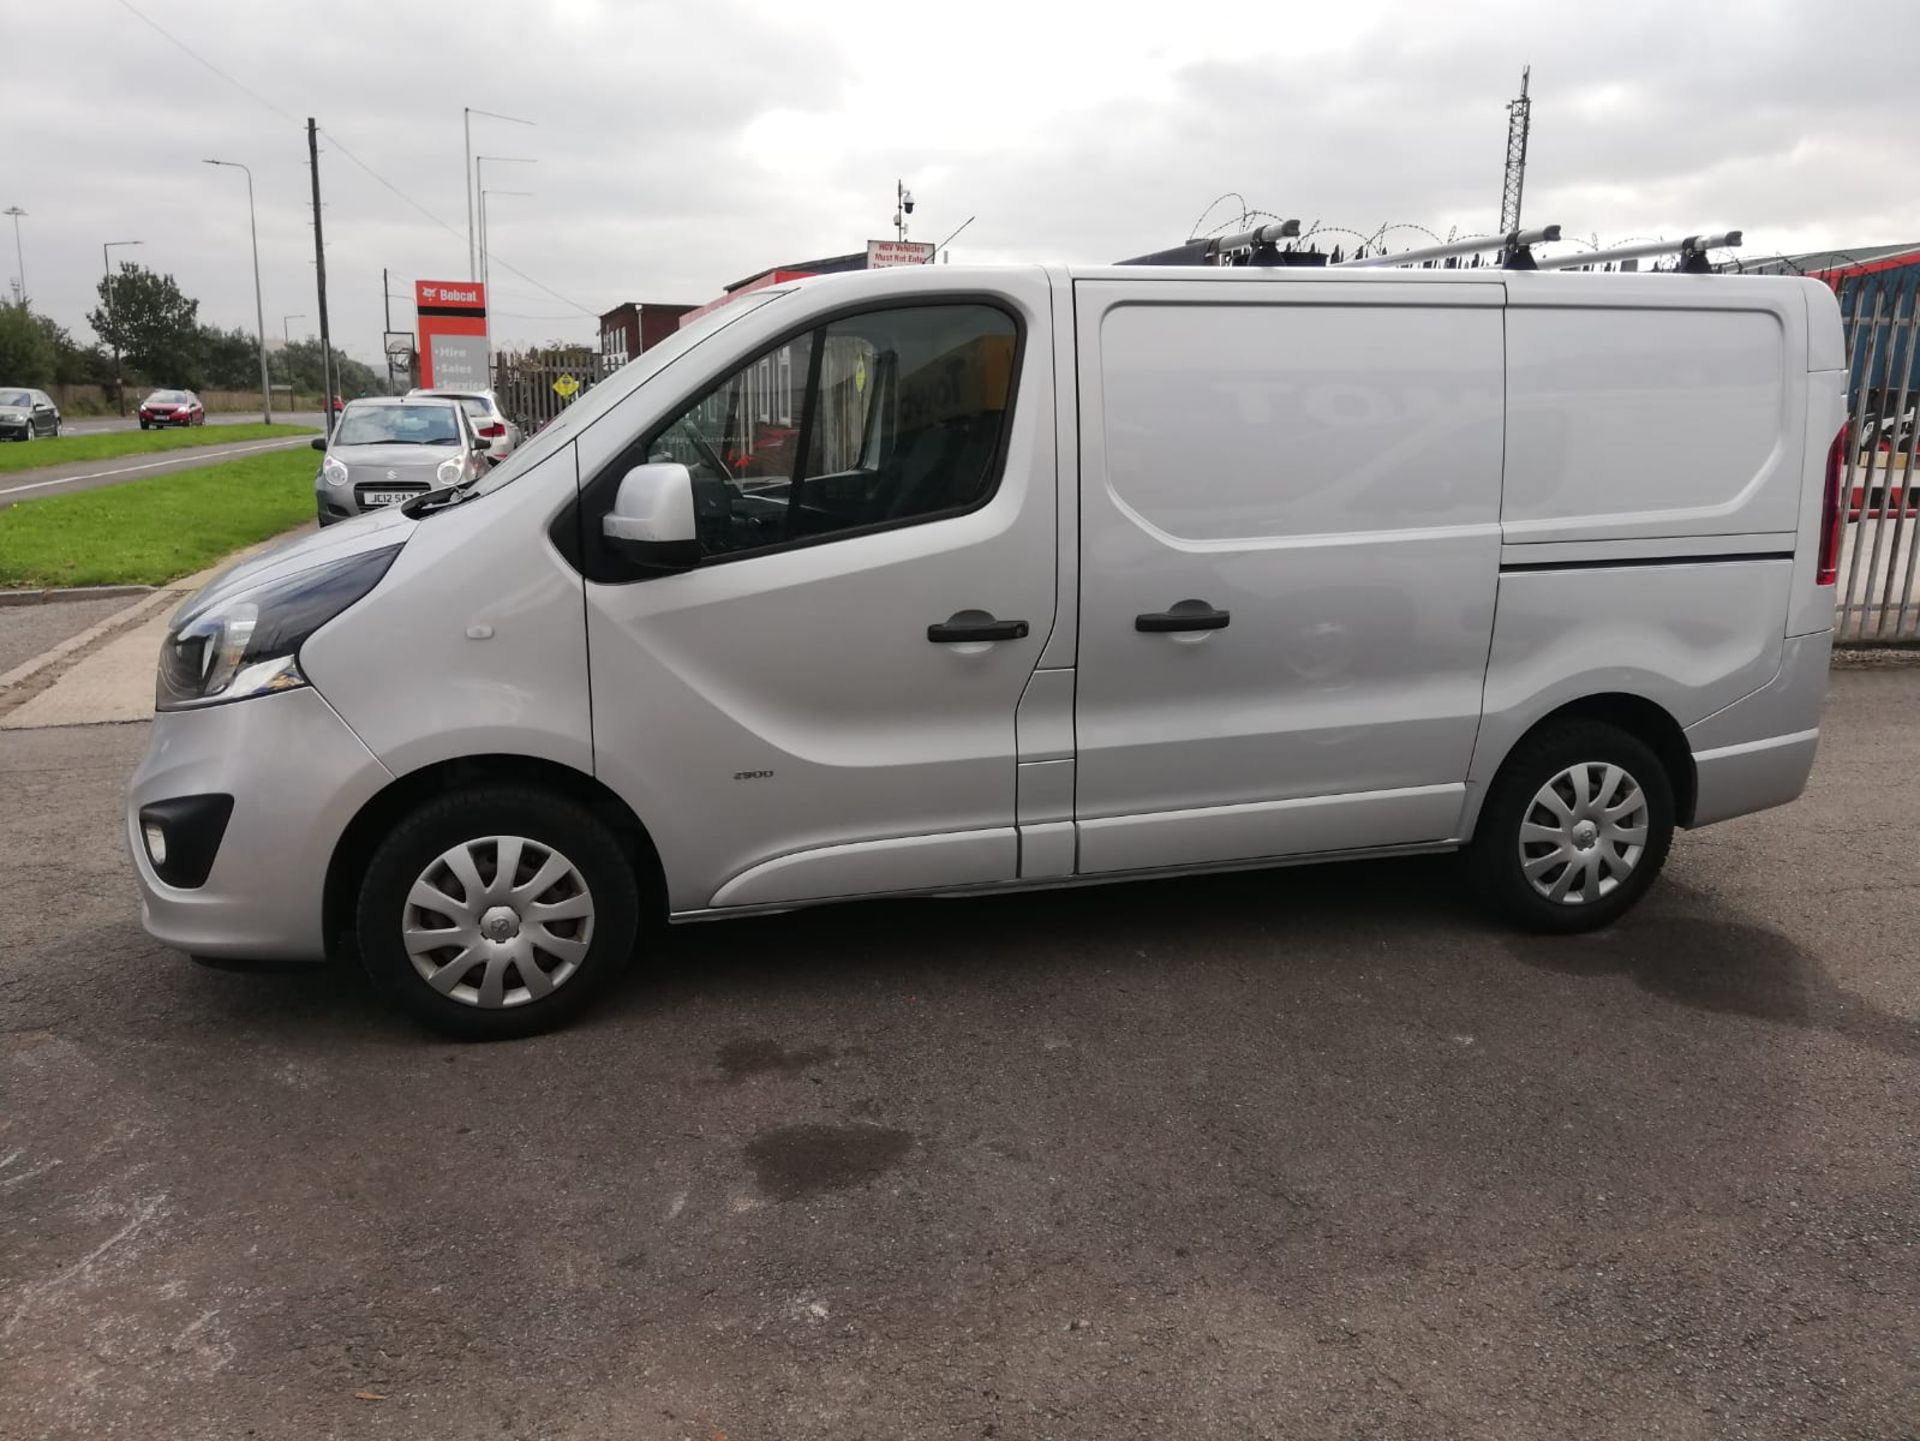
[{"xmin": 355, "ymin": 785, "xmax": 639, "ymax": 1040}]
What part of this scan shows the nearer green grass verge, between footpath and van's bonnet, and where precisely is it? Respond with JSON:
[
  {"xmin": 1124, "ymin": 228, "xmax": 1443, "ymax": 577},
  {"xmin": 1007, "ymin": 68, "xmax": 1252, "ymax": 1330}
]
[{"xmin": 0, "ymin": 451, "xmax": 315, "ymax": 587}]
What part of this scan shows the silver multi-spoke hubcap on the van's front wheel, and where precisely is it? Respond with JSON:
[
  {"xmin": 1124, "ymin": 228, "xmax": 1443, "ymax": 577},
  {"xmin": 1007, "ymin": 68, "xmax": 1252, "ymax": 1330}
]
[{"xmin": 401, "ymin": 835, "xmax": 593, "ymax": 1009}]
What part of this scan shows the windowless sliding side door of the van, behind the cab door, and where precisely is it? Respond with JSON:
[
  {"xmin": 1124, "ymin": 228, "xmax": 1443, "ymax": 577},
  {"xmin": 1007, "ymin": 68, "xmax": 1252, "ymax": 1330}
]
[{"xmin": 1075, "ymin": 276, "xmax": 1503, "ymax": 873}]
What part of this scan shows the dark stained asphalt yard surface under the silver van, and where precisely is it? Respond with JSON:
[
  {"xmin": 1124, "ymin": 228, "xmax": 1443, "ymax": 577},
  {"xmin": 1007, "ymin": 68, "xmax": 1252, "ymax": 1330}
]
[{"xmin": 0, "ymin": 668, "xmax": 1920, "ymax": 1441}]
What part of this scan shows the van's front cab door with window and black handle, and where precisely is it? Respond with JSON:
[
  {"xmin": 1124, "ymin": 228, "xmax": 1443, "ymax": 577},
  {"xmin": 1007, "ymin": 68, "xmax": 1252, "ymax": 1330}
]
[{"xmin": 582, "ymin": 271, "xmax": 1056, "ymax": 911}]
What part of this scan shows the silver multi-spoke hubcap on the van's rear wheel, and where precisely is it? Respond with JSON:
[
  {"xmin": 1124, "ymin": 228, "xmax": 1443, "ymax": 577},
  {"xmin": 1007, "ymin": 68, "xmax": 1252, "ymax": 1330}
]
[{"xmin": 1521, "ymin": 762, "xmax": 1647, "ymax": 906}]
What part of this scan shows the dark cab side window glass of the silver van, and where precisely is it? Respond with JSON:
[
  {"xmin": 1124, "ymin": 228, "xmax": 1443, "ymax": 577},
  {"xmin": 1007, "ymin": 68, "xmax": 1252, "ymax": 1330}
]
[{"xmin": 647, "ymin": 303, "xmax": 1018, "ymax": 558}]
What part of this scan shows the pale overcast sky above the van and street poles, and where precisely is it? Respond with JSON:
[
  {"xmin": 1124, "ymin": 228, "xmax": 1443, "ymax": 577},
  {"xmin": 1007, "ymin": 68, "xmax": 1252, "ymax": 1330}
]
[{"xmin": 0, "ymin": 0, "xmax": 1920, "ymax": 361}]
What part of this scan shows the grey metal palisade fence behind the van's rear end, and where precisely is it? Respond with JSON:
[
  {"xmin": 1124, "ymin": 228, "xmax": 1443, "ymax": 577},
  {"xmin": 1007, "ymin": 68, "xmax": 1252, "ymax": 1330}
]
[{"xmin": 1836, "ymin": 267, "xmax": 1920, "ymax": 645}]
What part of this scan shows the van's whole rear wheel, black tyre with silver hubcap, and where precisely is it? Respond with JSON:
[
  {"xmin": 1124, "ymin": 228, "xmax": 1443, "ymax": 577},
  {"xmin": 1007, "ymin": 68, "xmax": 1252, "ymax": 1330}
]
[{"xmin": 1467, "ymin": 720, "xmax": 1674, "ymax": 933}]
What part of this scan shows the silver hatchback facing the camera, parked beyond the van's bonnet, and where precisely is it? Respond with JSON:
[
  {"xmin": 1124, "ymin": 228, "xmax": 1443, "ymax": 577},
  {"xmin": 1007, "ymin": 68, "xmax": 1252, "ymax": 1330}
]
[{"xmin": 313, "ymin": 397, "xmax": 488, "ymax": 526}]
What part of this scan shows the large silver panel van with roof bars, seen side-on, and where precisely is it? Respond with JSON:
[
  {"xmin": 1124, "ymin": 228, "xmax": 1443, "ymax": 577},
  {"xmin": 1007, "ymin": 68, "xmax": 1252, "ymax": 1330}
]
[{"xmin": 127, "ymin": 267, "xmax": 1845, "ymax": 1036}]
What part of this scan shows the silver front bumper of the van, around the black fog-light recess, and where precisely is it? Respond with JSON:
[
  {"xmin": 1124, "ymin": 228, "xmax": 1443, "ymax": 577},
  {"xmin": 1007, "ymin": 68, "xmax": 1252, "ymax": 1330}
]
[{"xmin": 127, "ymin": 687, "xmax": 394, "ymax": 961}]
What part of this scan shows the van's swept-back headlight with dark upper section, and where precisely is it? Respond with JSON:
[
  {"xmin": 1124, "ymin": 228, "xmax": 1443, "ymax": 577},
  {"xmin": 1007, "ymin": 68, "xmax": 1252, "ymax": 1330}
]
[{"xmin": 154, "ymin": 545, "xmax": 399, "ymax": 710}]
